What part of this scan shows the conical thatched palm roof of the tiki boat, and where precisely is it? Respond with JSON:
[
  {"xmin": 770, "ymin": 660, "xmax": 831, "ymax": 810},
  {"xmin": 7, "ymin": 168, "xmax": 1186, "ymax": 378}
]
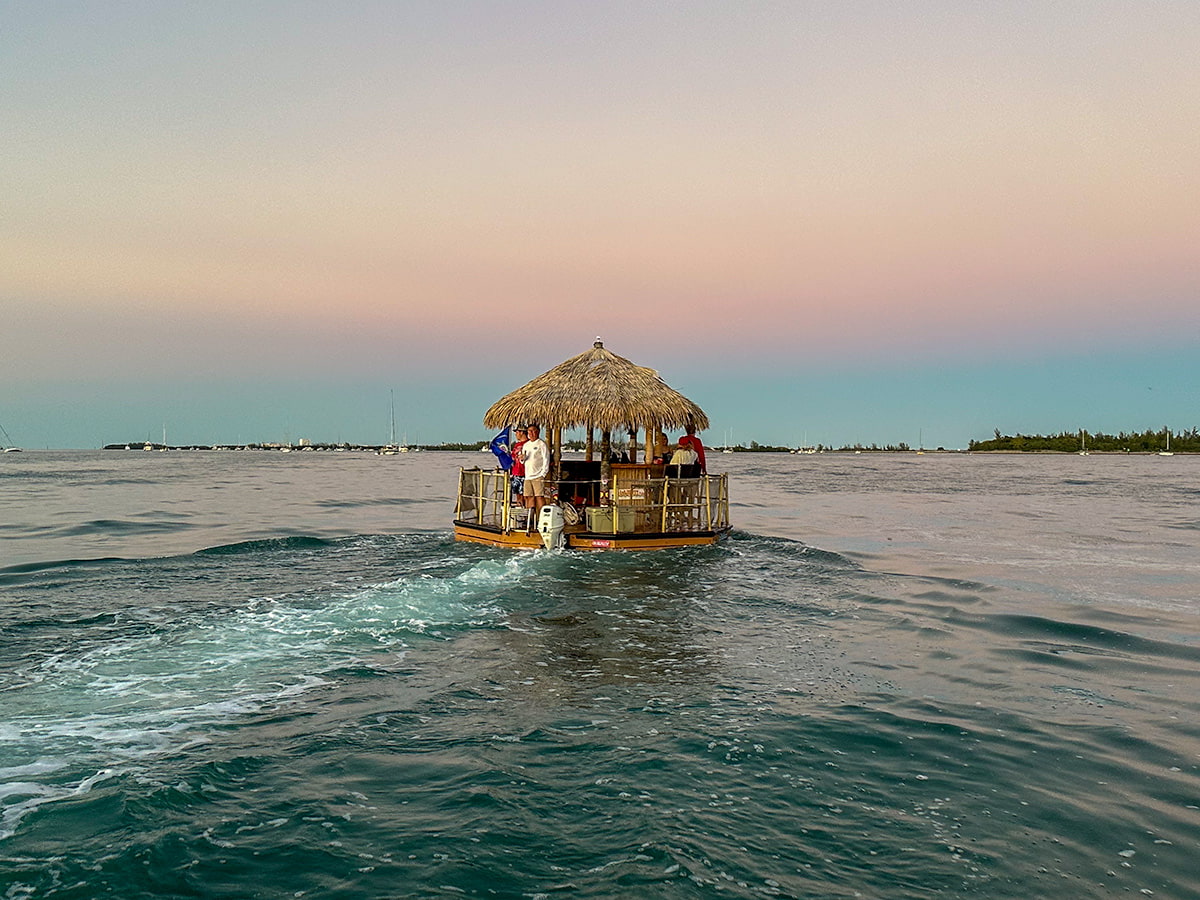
[{"xmin": 484, "ymin": 340, "xmax": 708, "ymax": 431}]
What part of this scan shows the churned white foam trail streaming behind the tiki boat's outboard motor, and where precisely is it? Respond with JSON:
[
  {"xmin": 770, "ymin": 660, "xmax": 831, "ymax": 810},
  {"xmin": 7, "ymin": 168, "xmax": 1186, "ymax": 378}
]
[{"xmin": 0, "ymin": 559, "xmax": 527, "ymax": 838}]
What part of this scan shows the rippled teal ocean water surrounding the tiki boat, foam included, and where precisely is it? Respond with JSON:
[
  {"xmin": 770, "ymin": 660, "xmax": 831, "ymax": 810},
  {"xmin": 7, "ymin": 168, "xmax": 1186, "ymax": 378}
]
[{"xmin": 0, "ymin": 451, "xmax": 1200, "ymax": 900}]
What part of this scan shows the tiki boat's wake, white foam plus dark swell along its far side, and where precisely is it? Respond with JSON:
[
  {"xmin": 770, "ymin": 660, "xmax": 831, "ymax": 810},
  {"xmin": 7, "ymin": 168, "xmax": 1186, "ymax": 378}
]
[{"xmin": 0, "ymin": 538, "xmax": 536, "ymax": 839}]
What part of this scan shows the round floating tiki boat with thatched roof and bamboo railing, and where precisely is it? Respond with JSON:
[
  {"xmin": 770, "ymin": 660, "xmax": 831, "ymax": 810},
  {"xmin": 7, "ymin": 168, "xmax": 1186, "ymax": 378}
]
[{"xmin": 454, "ymin": 338, "xmax": 730, "ymax": 550}]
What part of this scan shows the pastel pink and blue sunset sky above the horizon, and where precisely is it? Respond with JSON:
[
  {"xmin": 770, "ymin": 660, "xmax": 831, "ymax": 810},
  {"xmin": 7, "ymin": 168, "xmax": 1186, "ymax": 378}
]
[{"xmin": 0, "ymin": 0, "xmax": 1200, "ymax": 448}]
